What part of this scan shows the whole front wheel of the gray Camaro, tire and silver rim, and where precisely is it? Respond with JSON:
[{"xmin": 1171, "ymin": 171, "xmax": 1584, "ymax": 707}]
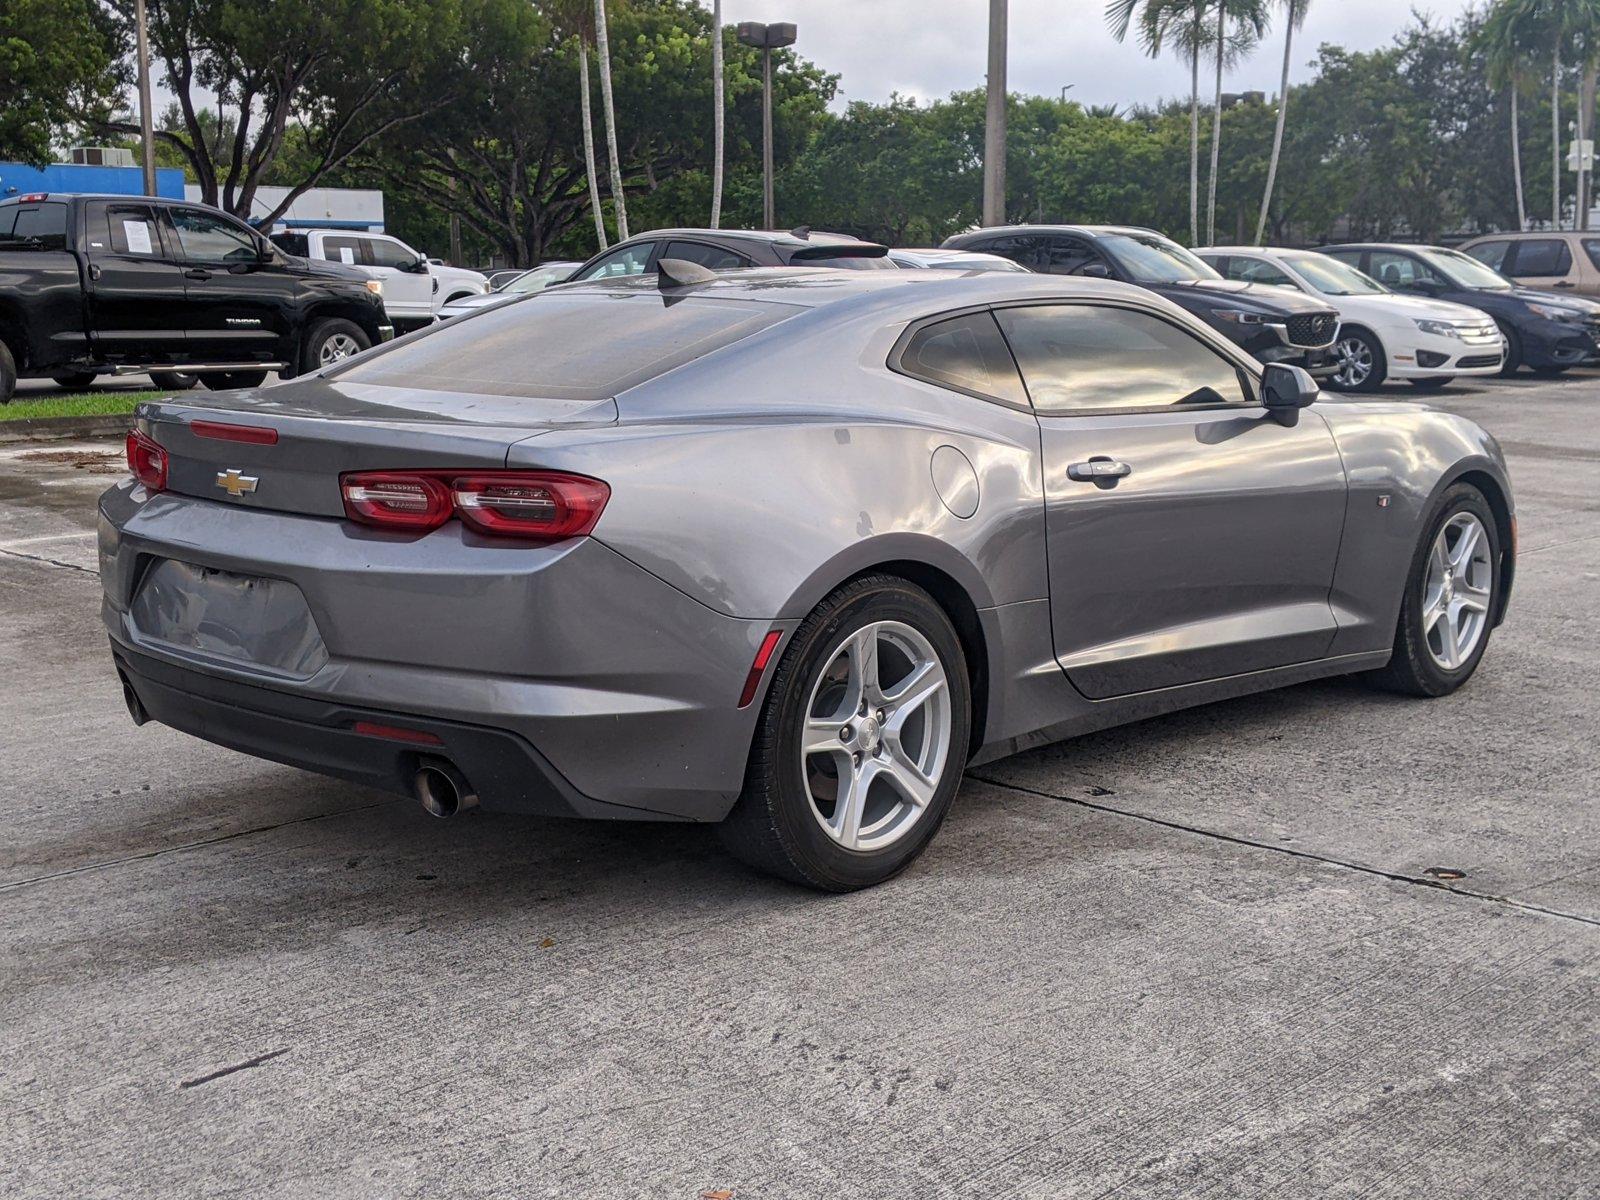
[{"xmin": 1371, "ymin": 483, "xmax": 1501, "ymax": 696}]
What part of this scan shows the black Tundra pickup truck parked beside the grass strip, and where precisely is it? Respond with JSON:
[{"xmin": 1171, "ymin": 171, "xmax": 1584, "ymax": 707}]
[{"xmin": 0, "ymin": 194, "xmax": 394, "ymax": 403}]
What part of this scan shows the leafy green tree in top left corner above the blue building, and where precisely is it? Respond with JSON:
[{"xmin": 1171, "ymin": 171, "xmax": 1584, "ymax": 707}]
[{"xmin": 0, "ymin": 0, "xmax": 128, "ymax": 166}]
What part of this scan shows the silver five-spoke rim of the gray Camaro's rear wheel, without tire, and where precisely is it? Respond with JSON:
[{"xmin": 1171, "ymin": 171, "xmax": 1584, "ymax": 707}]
[{"xmin": 800, "ymin": 621, "xmax": 952, "ymax": 851}]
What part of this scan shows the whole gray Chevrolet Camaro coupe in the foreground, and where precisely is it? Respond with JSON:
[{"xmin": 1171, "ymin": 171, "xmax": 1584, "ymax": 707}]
[{"xmin": 99, "ymin": 264, "xmax": 1515, "ymax": 890}]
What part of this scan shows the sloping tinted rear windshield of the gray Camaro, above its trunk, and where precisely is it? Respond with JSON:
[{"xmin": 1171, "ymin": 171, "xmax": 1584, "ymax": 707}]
[{"xmin": 330, "ymin": 291, "xmax": 803, "ymax": 400}]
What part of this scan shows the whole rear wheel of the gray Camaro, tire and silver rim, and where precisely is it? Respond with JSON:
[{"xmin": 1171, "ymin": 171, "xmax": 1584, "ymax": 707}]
[{"xmin": 720, "ymin": 574, "xmax": 971, "ymax": 891}]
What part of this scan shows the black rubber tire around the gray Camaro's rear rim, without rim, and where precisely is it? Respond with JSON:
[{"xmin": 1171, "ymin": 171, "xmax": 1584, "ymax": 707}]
[{"xmin": 718, "ymin": 574, "xmax": 971, "ymax": 891}]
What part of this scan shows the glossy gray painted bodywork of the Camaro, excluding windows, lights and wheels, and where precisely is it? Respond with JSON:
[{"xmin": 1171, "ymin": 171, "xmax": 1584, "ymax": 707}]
[{"xmin": 101, "ymin": 270, "xmax": 1510, "ymax": 819}]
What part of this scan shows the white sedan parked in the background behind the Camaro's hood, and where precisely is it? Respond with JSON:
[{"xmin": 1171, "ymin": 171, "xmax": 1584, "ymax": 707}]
[{"xmin": 1195, "ymin": 246, "xmax": 1506, "ymax": 392}]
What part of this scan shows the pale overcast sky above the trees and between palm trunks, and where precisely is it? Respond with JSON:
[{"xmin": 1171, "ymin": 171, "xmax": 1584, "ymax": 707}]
[{"xmin": 723, "ymin": 0, "xmax": 1472, "ymax": 106}]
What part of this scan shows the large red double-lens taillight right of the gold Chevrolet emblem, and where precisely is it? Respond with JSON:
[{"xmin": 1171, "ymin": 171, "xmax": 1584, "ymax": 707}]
[{"xmin": 339, "ymin": 470, "xmax": 611, "ymax": 541}]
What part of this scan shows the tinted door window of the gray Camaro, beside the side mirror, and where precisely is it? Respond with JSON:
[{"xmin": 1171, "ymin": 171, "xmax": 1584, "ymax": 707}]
[{"xmin": 997, "ymin": 304, "xmax": 1250, "ymax": 414}]
